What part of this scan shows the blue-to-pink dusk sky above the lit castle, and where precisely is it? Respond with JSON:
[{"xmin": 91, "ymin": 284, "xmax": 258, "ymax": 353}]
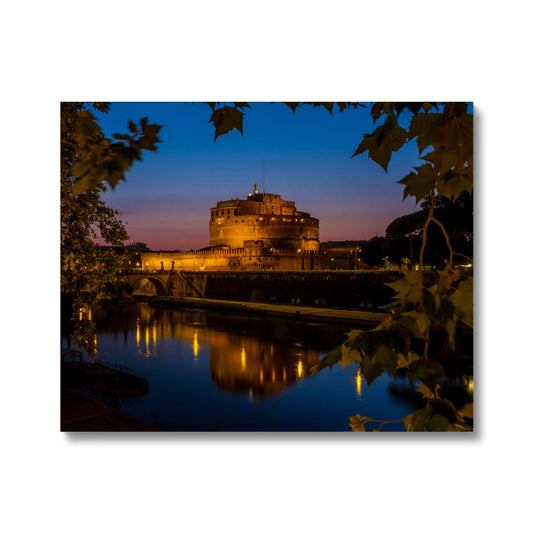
[{"xmin": 93, "ymin": 102, "xmax": 419, "ymax": 251}]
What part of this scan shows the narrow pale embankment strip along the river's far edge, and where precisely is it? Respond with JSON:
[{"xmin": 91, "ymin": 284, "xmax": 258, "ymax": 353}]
[{"xmin": 145, "ymin": 296, "xmax": 386, "ymax": 325}]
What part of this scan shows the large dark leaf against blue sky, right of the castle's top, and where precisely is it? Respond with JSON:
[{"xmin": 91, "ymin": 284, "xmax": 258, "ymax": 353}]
[{"xmin": 352, "ymin": 116, "xmax": 407, "ymax": 172}]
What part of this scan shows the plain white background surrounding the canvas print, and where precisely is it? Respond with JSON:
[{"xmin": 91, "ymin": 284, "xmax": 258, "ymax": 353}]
[{"xmin": 0, "ymin": 0, "xmax": 533, "ymax": 533}]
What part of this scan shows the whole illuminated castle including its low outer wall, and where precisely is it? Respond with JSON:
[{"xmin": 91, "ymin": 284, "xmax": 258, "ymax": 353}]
[{"xmin": 141, "ymin": 183, "xmax": 355, "ymax": 271}]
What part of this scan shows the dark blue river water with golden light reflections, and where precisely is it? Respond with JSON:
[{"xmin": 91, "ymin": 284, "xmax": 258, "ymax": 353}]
[{"xmin": 62, "ymin": 303, "xmax": 470, "ymax": 431}]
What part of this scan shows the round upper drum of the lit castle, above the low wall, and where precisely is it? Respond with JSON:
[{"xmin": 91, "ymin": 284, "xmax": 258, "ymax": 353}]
[{"xmin": 209, "ymin": 190, "xmax": 320, "ymax": 251}]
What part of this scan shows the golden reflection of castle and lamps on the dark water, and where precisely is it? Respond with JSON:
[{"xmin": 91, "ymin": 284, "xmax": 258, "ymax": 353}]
[{"xmin": 99, "ymin": 304, "xmax": 326, "ymax": 399}]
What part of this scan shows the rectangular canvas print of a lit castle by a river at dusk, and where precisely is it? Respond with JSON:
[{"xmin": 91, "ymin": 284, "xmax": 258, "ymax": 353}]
[{"xmin": 60, "ymin": 102, "xmax": 474, "ymax": 433}]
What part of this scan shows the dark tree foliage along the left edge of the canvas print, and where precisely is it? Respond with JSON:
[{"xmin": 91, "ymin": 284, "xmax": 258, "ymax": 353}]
[{"xmin": 60, "ymin": 103, "xmax": 160, "ymax": 353}]
